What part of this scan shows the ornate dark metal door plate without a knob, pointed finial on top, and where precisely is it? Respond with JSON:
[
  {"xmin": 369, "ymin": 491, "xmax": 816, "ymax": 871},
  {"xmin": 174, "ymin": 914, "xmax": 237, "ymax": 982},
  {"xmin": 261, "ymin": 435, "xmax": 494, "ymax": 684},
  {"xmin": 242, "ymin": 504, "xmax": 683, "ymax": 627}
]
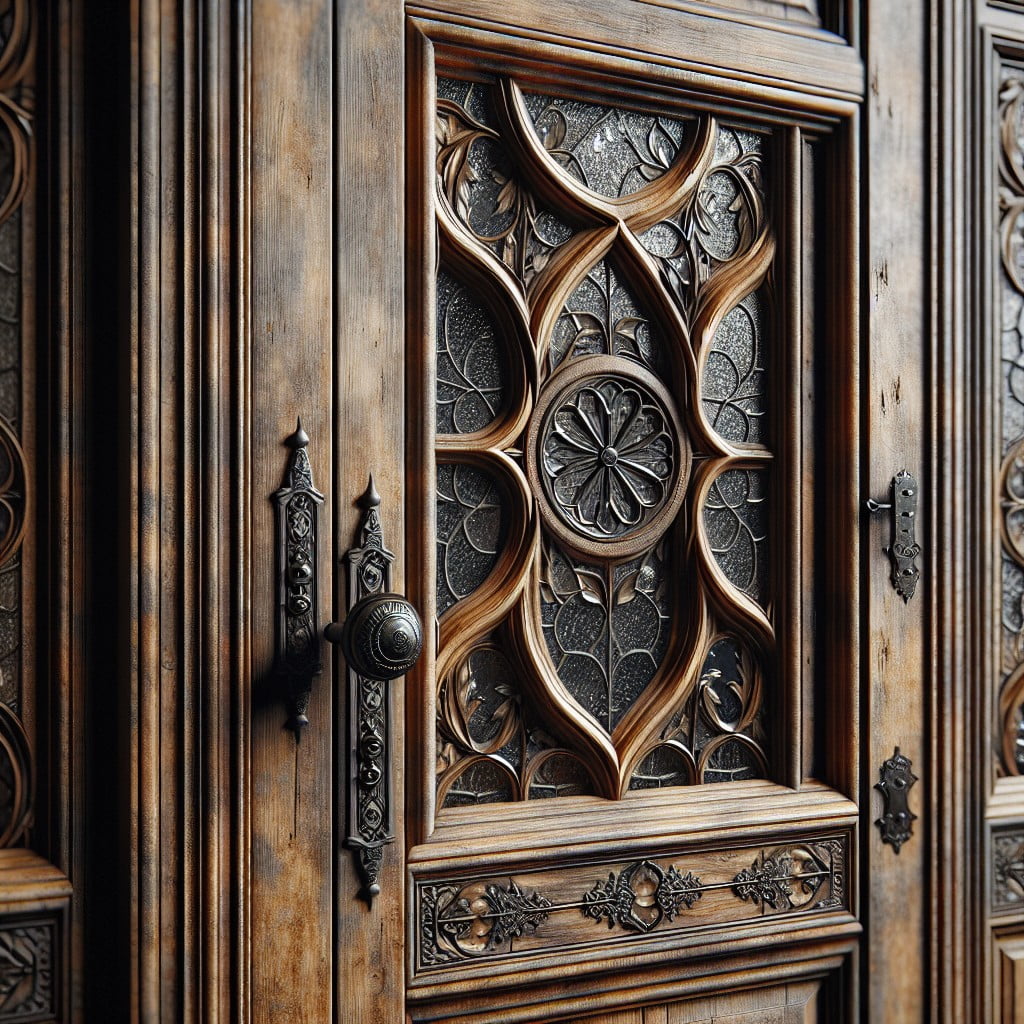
[{"xmin": 270, "ymin": 420, "xmax": 324, "ymax": 742}]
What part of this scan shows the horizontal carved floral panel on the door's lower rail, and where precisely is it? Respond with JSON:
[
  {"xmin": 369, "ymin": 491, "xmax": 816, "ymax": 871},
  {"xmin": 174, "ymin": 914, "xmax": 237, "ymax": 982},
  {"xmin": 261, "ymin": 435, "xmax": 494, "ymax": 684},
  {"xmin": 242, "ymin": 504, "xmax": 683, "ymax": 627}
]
[{"xmin": 416, "ymin": 835, "xmax": 849, "ymax": 971}]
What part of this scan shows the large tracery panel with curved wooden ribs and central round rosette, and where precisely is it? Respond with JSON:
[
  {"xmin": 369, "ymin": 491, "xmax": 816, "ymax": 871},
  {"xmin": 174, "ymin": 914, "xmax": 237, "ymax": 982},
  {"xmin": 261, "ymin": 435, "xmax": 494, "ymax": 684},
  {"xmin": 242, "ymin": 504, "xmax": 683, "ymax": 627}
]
[{"xmin": 434, "ymin": 77, "xmax": 774, "ymax": 807}]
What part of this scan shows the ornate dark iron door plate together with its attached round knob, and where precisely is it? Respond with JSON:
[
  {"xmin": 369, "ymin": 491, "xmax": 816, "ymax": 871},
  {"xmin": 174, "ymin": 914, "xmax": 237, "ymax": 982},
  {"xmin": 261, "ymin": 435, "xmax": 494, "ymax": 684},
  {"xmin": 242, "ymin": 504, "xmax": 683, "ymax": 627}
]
[{"xmin": 324, "ymin": 476, "xmax": 423, "ymax": 904}]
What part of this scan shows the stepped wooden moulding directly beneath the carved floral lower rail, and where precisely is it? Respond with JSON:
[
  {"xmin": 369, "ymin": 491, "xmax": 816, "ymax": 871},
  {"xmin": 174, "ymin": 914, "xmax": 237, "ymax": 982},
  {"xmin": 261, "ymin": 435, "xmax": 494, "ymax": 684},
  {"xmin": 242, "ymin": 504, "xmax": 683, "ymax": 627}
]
[{"xmin": 409, "ymin": 915, "xmax": 861, "ymax": 1024}]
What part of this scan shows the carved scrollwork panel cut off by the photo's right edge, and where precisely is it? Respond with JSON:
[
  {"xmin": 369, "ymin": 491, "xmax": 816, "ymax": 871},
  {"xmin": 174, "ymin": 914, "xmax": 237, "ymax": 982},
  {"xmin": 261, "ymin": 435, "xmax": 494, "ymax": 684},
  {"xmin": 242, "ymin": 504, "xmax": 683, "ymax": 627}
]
[{"xmin": 998, "ymin": 69, "xmax": 1024, "ymax": 775}]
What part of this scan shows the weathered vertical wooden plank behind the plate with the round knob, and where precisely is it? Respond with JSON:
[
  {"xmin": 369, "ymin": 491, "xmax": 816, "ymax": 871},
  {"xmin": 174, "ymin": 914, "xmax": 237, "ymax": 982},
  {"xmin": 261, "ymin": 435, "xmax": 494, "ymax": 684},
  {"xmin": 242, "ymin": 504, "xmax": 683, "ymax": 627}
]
[{"xmin": 333, "ymin": 0, "xmax": 403, "ymax": 1024}]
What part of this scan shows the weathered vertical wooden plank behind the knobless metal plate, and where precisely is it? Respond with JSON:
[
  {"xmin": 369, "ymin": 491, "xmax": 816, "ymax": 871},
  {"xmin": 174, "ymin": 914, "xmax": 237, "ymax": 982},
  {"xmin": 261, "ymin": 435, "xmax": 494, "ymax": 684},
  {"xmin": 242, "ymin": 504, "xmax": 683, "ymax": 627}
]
[{"xmin": 248, "ymin": 0, "xmax": 337, "ymax": 1024}]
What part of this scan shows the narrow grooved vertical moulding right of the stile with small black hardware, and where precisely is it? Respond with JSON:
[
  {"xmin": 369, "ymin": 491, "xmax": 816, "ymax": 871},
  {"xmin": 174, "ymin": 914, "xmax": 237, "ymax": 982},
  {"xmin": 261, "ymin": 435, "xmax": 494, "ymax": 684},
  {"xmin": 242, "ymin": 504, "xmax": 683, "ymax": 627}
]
[{"xmin": 926, "ymin": 3, "xmax": 974, "ymax": 1020}]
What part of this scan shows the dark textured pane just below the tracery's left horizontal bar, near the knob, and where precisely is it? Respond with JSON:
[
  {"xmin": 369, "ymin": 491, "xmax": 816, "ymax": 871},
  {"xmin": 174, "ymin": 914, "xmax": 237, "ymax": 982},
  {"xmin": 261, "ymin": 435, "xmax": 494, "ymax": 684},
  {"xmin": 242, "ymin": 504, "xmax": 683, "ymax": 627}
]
[{"xmin": 437, "ymin": 463, "xmax": 505, "ymax": 614}]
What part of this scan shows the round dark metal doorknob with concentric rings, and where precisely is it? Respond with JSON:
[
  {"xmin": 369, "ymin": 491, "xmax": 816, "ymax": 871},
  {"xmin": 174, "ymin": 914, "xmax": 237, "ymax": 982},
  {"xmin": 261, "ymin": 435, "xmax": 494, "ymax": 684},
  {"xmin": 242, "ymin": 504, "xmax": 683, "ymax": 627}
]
[{"xmin": 324, "ymin": 594, "xmax": 423, "ymax": 679}]
